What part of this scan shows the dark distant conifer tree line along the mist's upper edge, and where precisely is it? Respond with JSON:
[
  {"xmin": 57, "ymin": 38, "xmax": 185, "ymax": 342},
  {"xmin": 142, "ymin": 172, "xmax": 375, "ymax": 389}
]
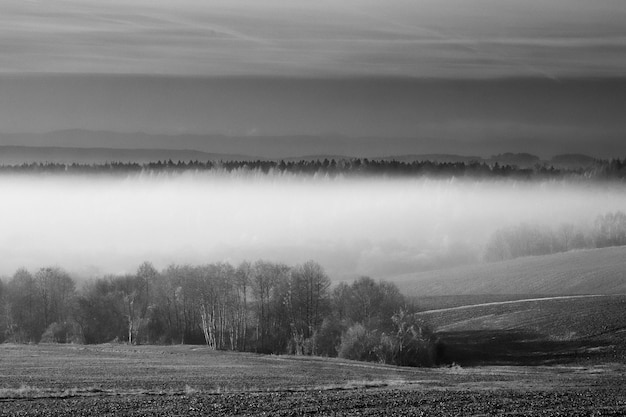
[{"xmin": 0, "ymin": 158, "xmax": 626, "ymax": 180}]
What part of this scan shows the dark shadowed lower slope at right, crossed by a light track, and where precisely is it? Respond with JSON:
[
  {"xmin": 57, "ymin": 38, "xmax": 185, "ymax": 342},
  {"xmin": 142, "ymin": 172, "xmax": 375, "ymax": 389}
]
[{"xmin": 420, "ymin": 295, "xmax": 626, "ymax": 365}]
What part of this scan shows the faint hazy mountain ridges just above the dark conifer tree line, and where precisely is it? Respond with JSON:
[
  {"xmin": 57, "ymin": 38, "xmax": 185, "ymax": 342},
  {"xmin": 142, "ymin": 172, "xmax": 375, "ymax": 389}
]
[{"xmin": 0, "ymin": 129, "xmax": 597, "ymax": 169}]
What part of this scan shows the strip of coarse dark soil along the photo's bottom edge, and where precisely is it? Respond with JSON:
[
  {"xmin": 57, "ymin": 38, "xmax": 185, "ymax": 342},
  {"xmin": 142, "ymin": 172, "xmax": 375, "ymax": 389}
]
[{"xmin": 0, "ymin": 387, "xmax": 626, "ymax": 416}]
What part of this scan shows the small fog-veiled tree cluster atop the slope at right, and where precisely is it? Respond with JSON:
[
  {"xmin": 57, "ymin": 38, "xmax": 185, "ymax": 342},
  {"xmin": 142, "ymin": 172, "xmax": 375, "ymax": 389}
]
[{"xmin": 485, "ymin": 211, "xmax": 626, "ymax": 262}]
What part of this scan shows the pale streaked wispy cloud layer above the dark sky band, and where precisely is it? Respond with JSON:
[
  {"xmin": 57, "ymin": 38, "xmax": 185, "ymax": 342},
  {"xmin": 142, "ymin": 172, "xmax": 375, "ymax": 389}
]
[{"xmin": 0, "ymin": 0, "xmax": 626, "ymax": 77}]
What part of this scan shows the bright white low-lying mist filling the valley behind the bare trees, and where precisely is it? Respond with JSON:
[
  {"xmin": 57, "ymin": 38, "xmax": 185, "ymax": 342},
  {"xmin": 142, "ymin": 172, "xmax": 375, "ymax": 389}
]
[{"xmin": 0, "ymin": 172, "xmax": 626, "ymax": 280}]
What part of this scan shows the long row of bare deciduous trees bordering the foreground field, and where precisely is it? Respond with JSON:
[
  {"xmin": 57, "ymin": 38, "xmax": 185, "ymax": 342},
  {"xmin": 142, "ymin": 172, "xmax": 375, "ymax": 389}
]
[{"xmin": 0, "ymin": 261, "xmax": 435, "ymax": 365}]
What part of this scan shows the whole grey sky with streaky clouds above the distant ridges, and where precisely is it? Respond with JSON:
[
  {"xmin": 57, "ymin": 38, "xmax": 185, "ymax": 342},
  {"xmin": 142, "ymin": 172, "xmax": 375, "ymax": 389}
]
[{"xmin": 0, "ymin": 0, "xmax": 626, "ymax": 157}]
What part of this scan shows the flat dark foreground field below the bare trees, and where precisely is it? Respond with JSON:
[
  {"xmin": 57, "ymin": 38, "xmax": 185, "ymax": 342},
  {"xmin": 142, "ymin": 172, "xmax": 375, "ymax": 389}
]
[{"xmin": 0, "ymin": 344, "xmax": 626, "ymax": 416}]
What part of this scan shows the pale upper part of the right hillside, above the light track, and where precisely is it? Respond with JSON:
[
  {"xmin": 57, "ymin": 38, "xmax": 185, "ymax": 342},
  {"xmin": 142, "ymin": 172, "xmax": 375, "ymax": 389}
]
[{"xmin": 393, "ymin": 246, "xmax": 626, "ymax": 298}]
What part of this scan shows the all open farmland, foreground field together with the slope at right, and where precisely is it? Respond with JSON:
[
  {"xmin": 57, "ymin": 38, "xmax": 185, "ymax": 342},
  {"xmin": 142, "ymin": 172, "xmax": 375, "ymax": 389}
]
[{"xmin": 0, "ymin": 248, "xmax": 626, "ymax": 416}]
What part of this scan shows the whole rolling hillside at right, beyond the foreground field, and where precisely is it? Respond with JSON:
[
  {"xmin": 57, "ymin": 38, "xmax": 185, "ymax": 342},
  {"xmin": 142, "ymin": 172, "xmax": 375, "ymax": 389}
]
[{"xmin": 395, "ymin": 247, "xmax": 626, "ymax": 365}]
